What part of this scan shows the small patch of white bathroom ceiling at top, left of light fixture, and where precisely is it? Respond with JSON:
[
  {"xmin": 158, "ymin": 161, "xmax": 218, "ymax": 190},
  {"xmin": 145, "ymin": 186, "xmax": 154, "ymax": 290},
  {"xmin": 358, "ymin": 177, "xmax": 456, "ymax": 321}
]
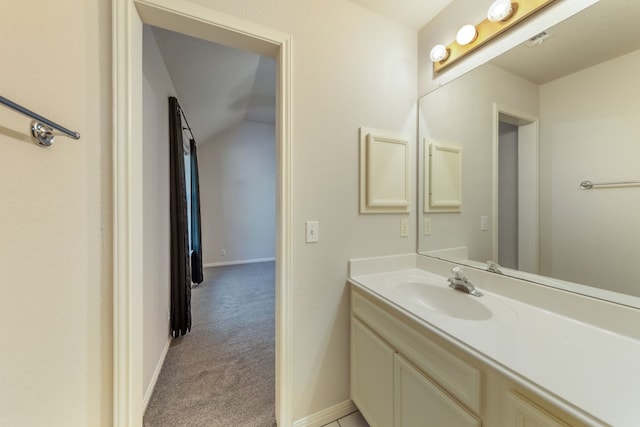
[{"xmin": 350, "ymin": 0, "xmax": 453, "ymax": 30}]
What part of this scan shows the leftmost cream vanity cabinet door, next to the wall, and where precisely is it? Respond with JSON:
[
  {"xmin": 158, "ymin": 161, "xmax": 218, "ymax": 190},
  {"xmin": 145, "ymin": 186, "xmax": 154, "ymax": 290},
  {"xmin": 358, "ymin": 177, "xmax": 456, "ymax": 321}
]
[{"xmin": 351, "ymin": 317, "xmax": 394, "ymax": 427}]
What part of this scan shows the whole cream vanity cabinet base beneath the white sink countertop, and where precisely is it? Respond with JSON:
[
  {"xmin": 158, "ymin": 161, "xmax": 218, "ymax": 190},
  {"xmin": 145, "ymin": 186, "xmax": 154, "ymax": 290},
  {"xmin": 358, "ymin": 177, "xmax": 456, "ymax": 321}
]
[{"xmin": 351, "ymin": 286, "xmax": 604, "ymax": 427}]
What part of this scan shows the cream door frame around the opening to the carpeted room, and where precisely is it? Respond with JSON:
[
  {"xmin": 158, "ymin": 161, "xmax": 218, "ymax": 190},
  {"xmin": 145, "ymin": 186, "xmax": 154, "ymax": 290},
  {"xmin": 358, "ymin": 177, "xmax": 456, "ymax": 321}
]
[{"xmin": 112, "ymin": 0, "xmax": 293, "ymax": 427}]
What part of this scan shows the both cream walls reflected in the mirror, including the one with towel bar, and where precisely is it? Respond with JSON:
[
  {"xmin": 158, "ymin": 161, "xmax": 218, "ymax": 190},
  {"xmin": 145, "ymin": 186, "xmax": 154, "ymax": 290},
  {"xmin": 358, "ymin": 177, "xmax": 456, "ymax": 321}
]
[{"xmin": 419, "ymin": 45, "xmax": 640, "ymax": 296}]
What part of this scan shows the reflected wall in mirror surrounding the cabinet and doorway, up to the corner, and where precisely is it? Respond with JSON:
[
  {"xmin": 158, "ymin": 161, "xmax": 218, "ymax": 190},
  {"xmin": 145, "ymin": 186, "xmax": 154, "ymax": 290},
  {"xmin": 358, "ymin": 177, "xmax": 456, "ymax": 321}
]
[{"xmin": 419, "ymin": 64, "xmax": 539, "ymax": 261}]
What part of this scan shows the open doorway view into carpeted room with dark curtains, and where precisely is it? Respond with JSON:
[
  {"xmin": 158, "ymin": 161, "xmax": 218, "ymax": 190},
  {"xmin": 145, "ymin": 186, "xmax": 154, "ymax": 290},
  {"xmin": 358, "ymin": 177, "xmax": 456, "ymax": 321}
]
[{"xmin": 143, "ymin": 20, "xmax": 276, "ymax": 426}]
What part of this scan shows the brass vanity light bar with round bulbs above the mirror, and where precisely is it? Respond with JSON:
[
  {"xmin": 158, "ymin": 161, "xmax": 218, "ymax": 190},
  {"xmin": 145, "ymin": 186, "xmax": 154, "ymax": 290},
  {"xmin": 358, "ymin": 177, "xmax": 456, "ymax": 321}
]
[{"xmin": 429, "ymin": 0, "xmax": 555, "ymax": 73}]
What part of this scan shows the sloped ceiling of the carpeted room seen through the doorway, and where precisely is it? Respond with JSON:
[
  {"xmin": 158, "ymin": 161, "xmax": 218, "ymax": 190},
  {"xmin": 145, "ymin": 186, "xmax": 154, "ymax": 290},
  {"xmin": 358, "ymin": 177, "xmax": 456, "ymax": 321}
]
[{"xmin": 152, "ymin": 27, "xmax": 276, "ymax": 143}]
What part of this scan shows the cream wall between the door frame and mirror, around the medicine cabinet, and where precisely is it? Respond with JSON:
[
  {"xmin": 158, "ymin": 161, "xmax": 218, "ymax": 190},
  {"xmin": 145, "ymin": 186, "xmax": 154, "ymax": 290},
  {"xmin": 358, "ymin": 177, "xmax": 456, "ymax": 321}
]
[{"xmin": 182, "ymin": 0, "xmax": 417, "ymax": 419}]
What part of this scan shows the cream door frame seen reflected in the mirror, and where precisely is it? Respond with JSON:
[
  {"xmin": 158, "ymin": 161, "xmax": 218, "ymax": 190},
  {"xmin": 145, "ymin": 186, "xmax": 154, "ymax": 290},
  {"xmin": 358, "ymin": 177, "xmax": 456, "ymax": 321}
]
[{"xmin": 492, "ymin": 103, "xmax": 539, "ymax": 274}]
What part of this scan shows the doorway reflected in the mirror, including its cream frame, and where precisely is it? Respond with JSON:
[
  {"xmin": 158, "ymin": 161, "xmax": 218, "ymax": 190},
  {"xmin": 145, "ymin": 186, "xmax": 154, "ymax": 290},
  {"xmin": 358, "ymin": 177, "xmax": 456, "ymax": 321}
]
[{"xmin": 493, "ymin": 104, "xmax": 538, "ymax": 273}]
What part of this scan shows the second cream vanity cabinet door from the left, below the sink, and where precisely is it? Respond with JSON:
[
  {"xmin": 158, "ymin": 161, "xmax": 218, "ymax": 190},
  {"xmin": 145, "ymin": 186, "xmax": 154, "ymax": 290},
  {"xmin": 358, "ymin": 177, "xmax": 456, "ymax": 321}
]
[{"xmin": 396, "ymin": 355, "xmax": 481, "ymax": 427}]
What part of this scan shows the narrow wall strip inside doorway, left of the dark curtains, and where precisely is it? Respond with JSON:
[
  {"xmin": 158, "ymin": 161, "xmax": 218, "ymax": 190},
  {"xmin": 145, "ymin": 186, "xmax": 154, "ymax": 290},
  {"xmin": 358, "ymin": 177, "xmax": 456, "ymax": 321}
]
[{"xmin": 142, "ymin": 26, "xmax": 176, "ymax": 404}]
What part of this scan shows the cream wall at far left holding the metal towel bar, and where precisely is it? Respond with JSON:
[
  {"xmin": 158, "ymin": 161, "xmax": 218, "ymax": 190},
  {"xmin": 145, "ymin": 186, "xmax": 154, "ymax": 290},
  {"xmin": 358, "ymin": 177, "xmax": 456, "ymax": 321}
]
[{"xmin": 0, "ymin": 0, "xmax": 113, "ymax": 427}]
